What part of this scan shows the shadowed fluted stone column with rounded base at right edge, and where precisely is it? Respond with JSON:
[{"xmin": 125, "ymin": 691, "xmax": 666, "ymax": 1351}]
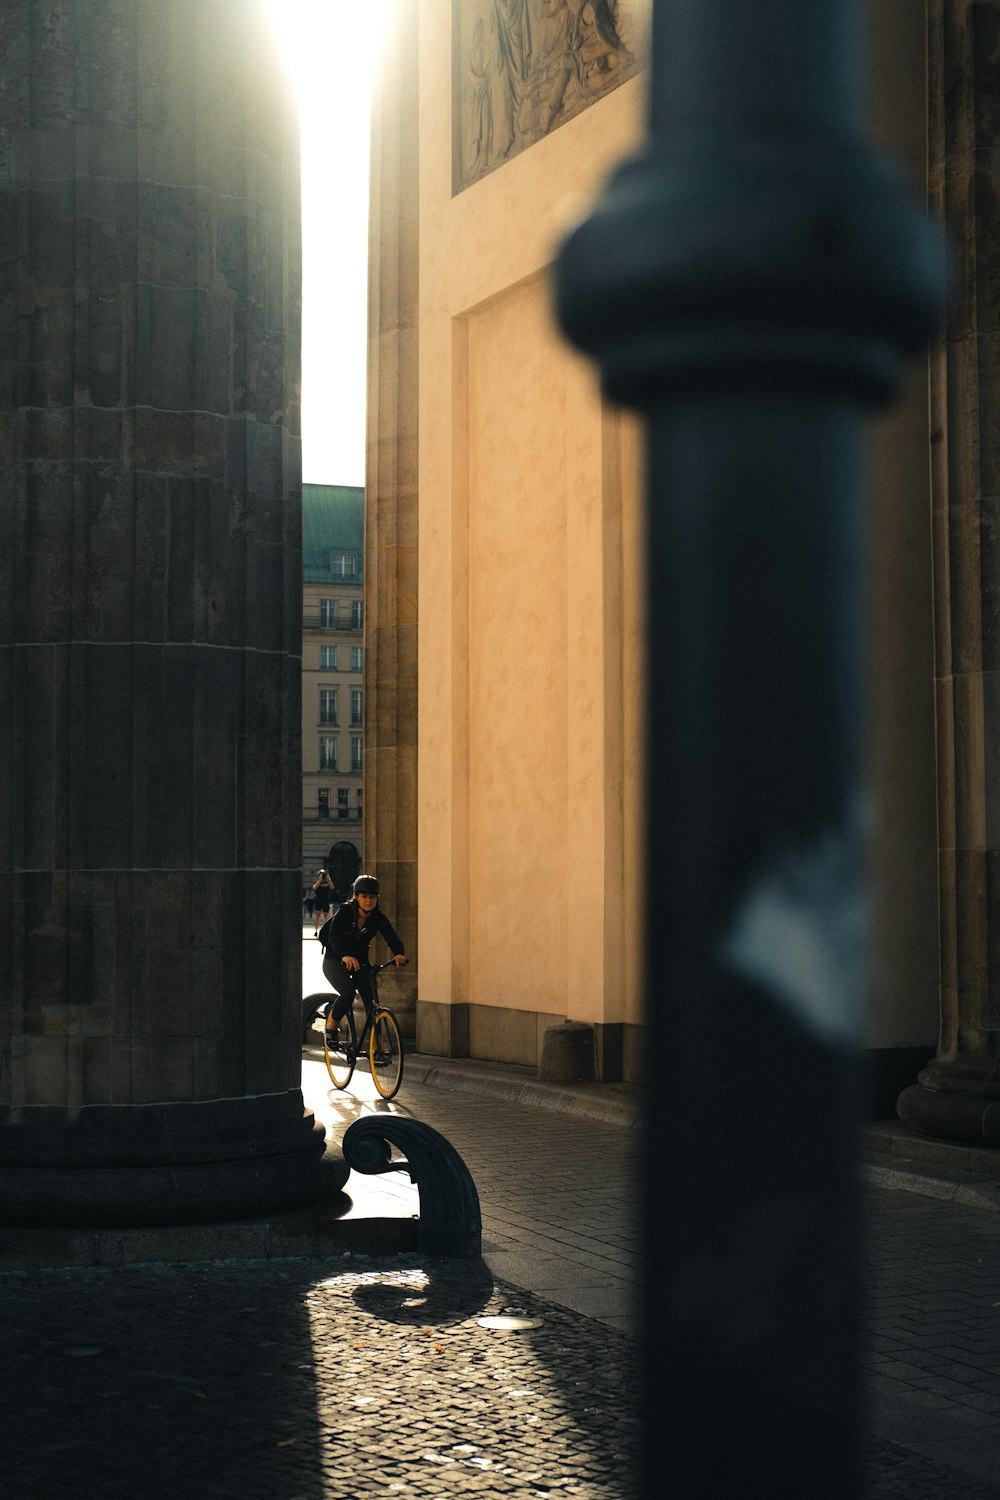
[{"xmin": 898, "ymin": 0, "xmax": 1000, "ymax": 1146}]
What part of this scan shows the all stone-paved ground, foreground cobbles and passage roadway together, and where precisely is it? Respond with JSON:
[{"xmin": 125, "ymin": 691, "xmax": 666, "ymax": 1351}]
[{"xmin": 0, "ymin": 966, "xmax": 1000, "ymax": 1500}]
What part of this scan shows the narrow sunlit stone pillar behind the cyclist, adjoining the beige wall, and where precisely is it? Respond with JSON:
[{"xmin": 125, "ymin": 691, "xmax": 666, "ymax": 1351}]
[{"xmin": 364, "ymin": 0, "xmax": 420, "ymax": 1038}]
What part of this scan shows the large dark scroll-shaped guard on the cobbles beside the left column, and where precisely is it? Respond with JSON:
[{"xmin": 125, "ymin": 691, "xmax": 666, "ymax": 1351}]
[{"xmin": 343, "ymin": 1115, "xmax": 483, "ymax": 1259}]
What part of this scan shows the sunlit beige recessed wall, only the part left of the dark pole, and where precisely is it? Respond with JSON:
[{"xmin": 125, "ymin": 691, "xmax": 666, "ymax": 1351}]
[{"xmin": 418, "ymin": 5, "xmax": 645, "ymax": 1062}]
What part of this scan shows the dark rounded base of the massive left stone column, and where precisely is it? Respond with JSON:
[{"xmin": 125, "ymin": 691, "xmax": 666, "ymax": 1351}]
[{"xmin": 0, "ymin": 1089, "xmax": 332, "ymax": 1229}]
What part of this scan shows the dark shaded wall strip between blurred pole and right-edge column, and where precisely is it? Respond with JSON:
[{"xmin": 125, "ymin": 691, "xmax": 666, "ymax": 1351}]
[{"xmin": 864, "ymin": 0, "xmax": 940, "ymax": 1119}]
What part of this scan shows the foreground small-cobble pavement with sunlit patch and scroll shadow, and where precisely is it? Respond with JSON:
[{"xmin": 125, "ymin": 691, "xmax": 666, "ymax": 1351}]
[{"xmin": 0, "ymin": 1259, "xmax": 636, "ymax": 1500}]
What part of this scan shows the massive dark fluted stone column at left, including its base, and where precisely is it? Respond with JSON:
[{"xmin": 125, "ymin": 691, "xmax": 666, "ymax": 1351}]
[{"xmin": 0, "ymin": 0, "xmax": 322, "ymax": 1224}]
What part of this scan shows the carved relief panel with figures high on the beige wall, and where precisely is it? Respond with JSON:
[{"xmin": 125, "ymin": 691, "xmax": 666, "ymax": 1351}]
[{"xmin": 451, "ymin": 0, "xmax": 651, "ymax": 192}]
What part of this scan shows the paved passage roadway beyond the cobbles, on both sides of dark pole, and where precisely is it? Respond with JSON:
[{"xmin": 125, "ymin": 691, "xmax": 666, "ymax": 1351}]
[{"xmin": 310, "ymin": 1056, "xmax": 1000, "ymax": 1500}]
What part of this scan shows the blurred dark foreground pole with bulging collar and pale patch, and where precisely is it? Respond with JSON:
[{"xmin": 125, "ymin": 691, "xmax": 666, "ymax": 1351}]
[{"xmin": 558, "ymin": 0, "xmax": 942, "ymax": 1500}]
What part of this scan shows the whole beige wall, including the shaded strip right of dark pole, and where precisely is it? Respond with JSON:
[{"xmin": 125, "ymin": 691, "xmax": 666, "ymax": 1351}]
[{"xmin": 418, "ymin": 0, "xmax": 939, "ymax": 1080}]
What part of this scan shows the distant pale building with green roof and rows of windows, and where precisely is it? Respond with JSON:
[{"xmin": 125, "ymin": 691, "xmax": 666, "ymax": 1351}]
[{"xmin": 301, "ymin": 485, "xmax": 371, "ymax": 893}]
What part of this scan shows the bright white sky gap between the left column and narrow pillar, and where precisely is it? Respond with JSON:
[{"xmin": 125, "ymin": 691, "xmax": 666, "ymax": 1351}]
[{"xmin": 268, "ymin": 0, "xmax": 390, "ymax": 485}]
